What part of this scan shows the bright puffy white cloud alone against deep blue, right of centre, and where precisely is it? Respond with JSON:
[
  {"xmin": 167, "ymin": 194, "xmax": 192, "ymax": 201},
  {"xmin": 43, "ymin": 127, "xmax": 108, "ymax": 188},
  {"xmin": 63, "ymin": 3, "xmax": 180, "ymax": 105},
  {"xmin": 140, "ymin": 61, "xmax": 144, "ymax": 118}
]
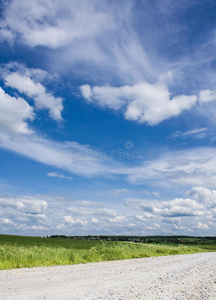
[{"xmin": 80, "ymin": 82, "xmax": 197, "ymax": 125}]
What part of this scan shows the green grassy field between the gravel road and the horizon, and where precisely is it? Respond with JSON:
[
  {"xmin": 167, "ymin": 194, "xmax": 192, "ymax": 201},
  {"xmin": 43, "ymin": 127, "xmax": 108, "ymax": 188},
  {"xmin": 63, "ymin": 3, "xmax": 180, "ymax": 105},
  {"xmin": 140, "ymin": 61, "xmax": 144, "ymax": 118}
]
[{"xmin": 0, "ymin": 235, "xmax": 216, "ymax": 270}]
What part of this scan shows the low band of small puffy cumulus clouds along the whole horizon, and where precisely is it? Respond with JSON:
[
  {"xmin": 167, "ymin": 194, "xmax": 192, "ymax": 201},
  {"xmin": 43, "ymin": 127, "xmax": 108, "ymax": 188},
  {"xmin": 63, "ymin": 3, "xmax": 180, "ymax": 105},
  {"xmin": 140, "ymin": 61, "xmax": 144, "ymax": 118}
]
[{"xmin": 0, "ymin": 187, "xmax": 216, "ymax": 235}]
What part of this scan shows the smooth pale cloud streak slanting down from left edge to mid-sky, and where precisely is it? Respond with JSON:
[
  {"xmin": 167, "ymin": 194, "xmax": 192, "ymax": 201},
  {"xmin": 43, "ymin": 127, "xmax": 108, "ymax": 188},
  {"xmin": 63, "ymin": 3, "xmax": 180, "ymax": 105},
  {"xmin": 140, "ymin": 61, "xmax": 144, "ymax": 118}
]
[{"xmin": 0, "ymin": 132, "xmax": 115, "ymax": 177}]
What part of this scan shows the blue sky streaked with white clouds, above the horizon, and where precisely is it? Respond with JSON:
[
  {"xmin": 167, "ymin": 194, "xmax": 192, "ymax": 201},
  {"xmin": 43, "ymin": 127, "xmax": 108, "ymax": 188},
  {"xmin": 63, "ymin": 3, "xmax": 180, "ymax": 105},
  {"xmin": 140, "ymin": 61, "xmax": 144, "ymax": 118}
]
[{"xmin": 0, "ymin": 0, "xmax": 216, "ymax": 235}]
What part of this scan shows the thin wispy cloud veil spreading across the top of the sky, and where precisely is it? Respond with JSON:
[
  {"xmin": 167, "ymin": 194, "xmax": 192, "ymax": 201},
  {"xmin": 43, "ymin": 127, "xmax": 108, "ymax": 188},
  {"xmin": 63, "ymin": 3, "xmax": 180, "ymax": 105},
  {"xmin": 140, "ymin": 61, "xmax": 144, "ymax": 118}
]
[{"xmin": 0, "ymin": 0, "xmax": 214, "ymax": 95}]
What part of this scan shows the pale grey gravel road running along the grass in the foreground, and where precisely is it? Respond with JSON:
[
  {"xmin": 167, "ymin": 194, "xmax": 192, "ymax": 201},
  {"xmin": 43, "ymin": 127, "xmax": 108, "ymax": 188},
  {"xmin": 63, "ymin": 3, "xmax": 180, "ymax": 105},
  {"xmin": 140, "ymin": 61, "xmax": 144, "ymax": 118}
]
[{"xmin": 0, "ymin": 252, "xmax": 216, "ymax": 300}]
